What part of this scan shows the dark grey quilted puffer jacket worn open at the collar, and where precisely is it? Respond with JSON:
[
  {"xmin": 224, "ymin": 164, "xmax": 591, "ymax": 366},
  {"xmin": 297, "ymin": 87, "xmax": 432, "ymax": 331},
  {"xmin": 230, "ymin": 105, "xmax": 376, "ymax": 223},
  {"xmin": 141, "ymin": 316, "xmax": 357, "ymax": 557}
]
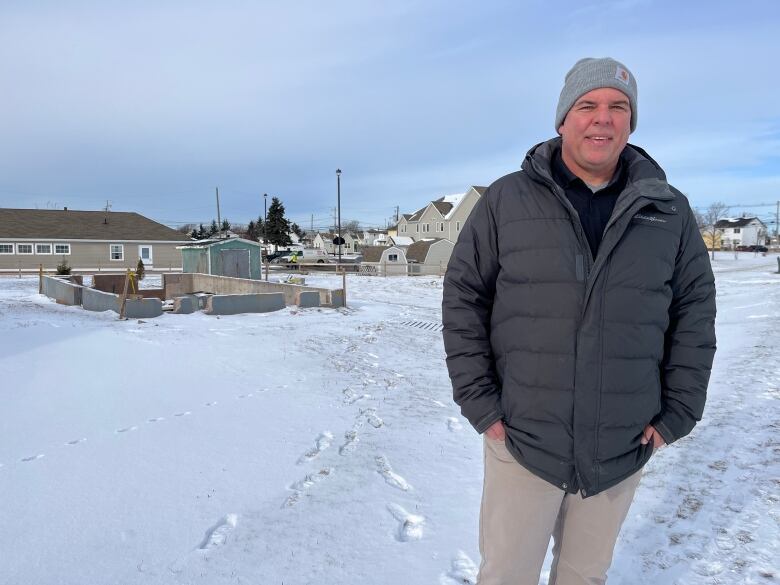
[{"xmin": 442, "ymin": 138, "xmax": 715, "ymax": 497}]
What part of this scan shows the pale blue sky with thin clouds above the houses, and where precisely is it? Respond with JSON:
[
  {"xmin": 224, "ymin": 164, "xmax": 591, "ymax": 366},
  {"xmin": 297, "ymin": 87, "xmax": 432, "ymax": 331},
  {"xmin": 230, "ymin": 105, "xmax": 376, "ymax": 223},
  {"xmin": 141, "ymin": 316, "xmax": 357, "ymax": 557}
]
[{"xmin": 0, "ymin": 0, "xmax": 780, "ymax": 228}]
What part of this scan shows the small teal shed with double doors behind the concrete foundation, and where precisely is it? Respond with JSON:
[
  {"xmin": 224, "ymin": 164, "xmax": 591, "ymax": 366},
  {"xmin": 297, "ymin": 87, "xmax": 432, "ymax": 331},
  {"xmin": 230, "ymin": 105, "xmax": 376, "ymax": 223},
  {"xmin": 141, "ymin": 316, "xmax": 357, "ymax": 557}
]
[{"xmin": 178, "ymin": 238, "xmax": 262, "ymax": 280}]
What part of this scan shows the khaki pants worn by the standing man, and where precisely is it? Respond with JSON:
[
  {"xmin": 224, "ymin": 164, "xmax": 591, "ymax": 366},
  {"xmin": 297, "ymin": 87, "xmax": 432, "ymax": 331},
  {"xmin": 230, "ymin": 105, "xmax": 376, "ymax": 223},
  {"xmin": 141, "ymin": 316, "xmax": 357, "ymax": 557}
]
[{"xmin": 477, "ymin": 437, "xmax": 642, "ymax": 585}]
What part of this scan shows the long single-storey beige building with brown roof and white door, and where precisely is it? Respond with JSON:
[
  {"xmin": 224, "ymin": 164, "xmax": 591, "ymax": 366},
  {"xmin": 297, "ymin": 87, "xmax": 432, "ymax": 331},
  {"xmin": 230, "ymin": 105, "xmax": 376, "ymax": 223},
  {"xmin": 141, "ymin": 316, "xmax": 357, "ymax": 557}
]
[{"xmin": 0, "ymin": 208, "xmax": 192, "ymax": 272}]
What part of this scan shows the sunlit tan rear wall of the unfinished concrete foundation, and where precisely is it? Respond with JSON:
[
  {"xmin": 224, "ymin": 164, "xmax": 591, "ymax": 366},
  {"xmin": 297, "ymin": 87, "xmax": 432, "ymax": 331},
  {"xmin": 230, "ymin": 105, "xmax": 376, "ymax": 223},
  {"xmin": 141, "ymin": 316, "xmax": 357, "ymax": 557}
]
[{"xmin": 163, "ymin": 274, "xmax": 341, "ymax": 306}]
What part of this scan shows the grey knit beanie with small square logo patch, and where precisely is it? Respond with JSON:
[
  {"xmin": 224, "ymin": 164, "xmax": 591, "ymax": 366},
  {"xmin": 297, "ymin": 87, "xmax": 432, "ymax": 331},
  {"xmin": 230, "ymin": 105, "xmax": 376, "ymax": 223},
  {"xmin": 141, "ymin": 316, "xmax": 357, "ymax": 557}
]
[{"xmin": 555, "ymin": 57, "xmax": 637, "ymax": 132}]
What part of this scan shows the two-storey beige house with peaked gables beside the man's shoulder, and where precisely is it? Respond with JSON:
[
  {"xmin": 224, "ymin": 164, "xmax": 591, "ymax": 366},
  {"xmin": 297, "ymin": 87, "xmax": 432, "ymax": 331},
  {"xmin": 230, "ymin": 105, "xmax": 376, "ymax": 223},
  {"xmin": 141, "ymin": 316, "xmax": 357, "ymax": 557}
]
[{"xmin": 397, "ymin": 186, "xmax": 487, "ymax": 244}]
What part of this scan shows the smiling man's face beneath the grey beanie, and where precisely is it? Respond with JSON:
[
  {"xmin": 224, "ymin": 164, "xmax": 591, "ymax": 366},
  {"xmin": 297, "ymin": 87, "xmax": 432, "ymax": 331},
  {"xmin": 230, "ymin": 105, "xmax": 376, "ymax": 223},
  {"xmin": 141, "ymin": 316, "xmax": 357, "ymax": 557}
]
[{"xmin": 558, "ymin": 87, "xmax": 631, "ymax": 185}]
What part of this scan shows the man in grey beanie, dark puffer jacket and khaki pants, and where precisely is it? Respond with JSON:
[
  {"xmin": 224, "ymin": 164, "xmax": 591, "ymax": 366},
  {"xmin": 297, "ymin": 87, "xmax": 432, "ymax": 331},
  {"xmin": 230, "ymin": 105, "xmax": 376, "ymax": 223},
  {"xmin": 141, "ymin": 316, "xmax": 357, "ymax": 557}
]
[{"xmin": 442, "ymin": 58, "xmax": 715, "ymax": 585}]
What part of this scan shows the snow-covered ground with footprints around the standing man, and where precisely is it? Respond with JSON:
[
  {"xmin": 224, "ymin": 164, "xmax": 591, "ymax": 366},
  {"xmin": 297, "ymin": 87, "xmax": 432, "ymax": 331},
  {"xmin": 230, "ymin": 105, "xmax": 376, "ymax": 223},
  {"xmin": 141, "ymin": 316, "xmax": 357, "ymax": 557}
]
[{"xmin": 0, "ymin": 253, "xmax": 780, "ymax": 585}]
